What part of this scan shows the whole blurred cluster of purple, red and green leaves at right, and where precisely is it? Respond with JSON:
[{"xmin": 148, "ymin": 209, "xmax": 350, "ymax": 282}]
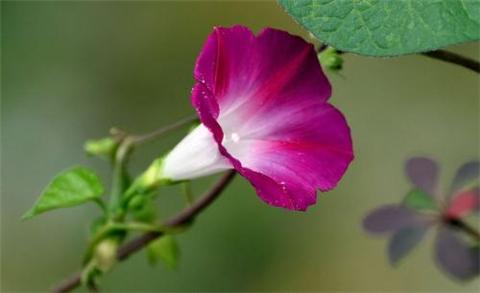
[{"xmin": 363, "ymin": 158, "xmax": 480, "ymax": 280}]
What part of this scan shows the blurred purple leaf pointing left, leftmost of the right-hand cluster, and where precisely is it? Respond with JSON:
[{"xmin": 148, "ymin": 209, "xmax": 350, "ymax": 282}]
[{"xmin": 363, "ymin": 205, "xmax": 433, "ymax": 234}]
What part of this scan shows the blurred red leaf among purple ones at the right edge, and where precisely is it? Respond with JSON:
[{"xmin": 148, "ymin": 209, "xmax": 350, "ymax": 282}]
[{"xmin": 444, "ymin": 187, "xmax": 480, "ymax": 219}]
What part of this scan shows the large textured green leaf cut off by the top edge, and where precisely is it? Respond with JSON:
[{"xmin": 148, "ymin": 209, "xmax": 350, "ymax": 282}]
[{"xmin": 279, "ymin": 0, "xmax": 480, "ymax": 56}]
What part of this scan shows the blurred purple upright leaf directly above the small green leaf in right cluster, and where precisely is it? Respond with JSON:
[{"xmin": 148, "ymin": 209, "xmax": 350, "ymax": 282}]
[{"xmin": 405, "ymin": 157, "xmax": 438, "ymax": 196}]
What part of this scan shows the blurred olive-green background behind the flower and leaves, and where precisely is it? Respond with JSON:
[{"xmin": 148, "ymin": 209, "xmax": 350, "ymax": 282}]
[{"xmin": 0, "ymin": 1, "xmax": 480, "ymax": 292}]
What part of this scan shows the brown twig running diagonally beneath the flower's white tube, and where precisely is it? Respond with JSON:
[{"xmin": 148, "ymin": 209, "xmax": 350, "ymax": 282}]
[{"xmin": 52, "ymin": 171, "xmax": 236, "ymax": 292}]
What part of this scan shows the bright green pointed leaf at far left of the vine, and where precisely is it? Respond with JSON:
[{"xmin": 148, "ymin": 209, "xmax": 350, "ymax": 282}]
[{"xmin": 23, "ymin": 167, "xmax": 104, "ymax": 219}]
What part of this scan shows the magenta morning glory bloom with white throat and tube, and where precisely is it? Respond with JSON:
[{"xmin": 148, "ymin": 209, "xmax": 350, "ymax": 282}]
[{"xmin": 160, "ymin": 26, "xmax": 353, "ymax": 210}]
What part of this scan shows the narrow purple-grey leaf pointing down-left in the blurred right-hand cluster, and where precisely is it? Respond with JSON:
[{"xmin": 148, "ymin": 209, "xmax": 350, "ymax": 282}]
[{"xmin": 388, "ymin": 225, "xmax": 430, "ymax": 265}]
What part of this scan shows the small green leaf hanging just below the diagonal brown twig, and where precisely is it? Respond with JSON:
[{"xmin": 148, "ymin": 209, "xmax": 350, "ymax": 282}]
[{"xmin": 147, "ymin": 235, "xmax": 180, "ymax": 269}]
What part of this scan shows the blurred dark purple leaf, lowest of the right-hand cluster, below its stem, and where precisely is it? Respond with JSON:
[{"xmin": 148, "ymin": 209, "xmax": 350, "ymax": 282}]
[{"xmin": 435, "ymin": 227, "xmax": 480, "ymax": 281}]
